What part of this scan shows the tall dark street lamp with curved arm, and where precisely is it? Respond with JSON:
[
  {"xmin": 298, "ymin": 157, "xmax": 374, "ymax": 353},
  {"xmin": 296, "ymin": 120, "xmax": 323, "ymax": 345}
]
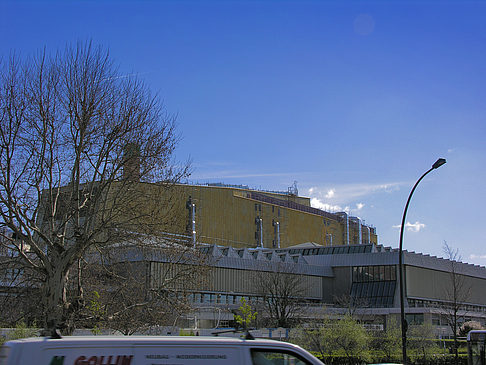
[{"xmin": 398, "ymin": 158, "xmax": 446, "ymax": 365}]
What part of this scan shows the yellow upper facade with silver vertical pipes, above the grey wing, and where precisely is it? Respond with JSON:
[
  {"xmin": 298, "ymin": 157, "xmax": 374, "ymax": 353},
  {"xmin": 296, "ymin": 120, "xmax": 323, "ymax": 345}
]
[{"xmin": 169, "ymin": 184, "xmax": 377, "ymax": 248}]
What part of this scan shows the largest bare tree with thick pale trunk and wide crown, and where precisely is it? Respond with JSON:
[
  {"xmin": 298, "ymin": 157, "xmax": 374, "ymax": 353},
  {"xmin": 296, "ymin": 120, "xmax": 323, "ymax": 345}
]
[{"xmin": 0, "ymin": 42, "xmax": 187, "ymax": 331}]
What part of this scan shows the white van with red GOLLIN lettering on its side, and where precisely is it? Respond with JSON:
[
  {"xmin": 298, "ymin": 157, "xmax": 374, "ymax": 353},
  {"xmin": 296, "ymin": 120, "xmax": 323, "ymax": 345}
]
[{"xmin": 0, "ymin": 336, "xmax": 322, "ymax": 365}]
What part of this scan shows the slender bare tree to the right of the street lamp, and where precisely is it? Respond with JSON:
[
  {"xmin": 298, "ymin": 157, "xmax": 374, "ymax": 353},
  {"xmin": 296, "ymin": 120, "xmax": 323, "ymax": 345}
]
[{"xmin": 442, "ymin": 242, "xmax": 471, "ymax": 364}]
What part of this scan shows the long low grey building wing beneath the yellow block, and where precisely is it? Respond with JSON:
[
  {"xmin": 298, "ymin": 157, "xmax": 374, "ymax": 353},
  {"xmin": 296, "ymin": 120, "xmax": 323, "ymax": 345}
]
[{"xmin": 117, "ymin": 239, "xmax": 486, "ymax": 338}]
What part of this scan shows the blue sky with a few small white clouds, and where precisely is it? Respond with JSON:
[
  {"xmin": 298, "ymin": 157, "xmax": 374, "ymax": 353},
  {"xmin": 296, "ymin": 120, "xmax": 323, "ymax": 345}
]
[{"xmin": 0, "ymin": 0, "xmax": 486, "ymax": 265}]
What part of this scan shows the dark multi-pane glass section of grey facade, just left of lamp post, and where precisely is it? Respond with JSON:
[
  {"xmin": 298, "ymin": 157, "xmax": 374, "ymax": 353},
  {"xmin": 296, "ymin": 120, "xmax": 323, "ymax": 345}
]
[{"xmin": 351, "ymin": 265, "xmax": 397, "ymax": 308}]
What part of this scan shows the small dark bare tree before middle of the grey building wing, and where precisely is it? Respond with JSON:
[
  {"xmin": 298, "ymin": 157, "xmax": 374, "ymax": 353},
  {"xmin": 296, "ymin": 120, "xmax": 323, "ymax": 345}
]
[{"xmin": 254, "ymin": 262, "xmax": 305, "ymax": 328}]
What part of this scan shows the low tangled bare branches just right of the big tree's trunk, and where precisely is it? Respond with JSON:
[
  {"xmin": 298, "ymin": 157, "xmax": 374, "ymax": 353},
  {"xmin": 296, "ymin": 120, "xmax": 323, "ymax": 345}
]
[{"xmin": 79, "ymin": 245, "xmax": 208, "ymax": 335}]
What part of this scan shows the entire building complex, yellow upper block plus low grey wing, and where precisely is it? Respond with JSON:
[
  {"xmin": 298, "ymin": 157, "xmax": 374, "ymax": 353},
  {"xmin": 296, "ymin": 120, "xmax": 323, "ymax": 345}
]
[{"xmin": 0, "ymin": 183, "xmax": 486, "ymax": 337}]
